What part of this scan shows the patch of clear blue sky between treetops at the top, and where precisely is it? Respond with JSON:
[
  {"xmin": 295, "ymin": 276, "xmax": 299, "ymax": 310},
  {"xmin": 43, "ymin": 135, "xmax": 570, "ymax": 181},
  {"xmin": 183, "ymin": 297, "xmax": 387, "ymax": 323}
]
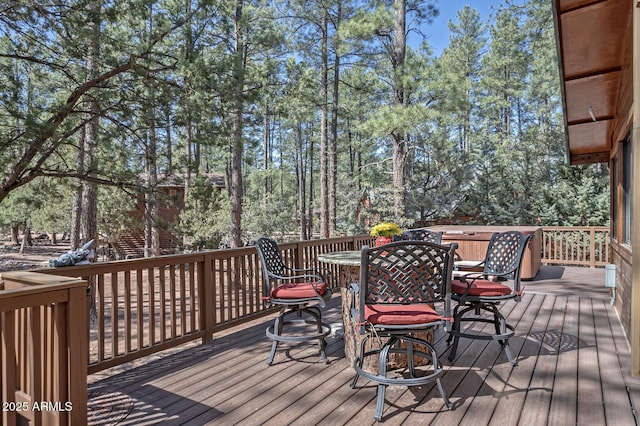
[{"xmin": 423, "ymin": 0, "xmax": 522, "ymax": 56}]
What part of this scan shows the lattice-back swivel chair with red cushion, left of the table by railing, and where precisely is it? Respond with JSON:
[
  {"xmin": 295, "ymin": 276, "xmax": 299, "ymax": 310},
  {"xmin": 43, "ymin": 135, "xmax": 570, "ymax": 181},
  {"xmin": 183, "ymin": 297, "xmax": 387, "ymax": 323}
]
[{"xmin": 255, "ymin": 238, "xmax": 331, "ymax": 365}]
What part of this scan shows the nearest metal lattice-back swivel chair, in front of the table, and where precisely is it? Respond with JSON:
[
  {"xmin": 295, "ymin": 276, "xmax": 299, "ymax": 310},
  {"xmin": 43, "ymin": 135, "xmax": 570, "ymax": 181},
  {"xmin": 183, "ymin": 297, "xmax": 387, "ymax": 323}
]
[{"xmin": 350, "ymin": 241, "xmax": 457, "ymax": 421}]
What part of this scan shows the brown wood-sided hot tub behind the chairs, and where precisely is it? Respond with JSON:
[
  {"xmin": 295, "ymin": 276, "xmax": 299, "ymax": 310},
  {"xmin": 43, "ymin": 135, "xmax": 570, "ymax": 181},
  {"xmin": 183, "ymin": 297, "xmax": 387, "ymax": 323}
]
[{"xmin": 427, "ymin": 225, "xmax": 542, "ymax": 280}]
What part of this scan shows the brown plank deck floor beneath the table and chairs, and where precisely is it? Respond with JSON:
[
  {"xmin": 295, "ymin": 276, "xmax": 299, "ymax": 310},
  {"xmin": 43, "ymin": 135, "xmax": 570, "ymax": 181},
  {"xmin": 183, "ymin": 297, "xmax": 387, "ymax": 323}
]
[{"xmin": 89, "ymin": 266, "xmax": 640, "ymax": 426}]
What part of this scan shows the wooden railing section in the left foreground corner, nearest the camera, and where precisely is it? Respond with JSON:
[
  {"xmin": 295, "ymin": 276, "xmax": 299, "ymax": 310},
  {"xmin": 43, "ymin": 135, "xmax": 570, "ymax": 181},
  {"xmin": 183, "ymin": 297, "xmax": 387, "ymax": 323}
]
[{"xmin": 0, "ymin": 272, "xmax": 87, "ymax": 426}]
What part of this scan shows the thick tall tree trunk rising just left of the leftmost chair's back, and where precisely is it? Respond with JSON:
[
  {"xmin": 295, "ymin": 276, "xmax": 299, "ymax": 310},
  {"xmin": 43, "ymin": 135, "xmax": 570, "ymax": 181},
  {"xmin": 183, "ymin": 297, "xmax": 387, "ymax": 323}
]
[{"xmin": 230, "ymin": 0, "xmax": 245, "ymax": 247}]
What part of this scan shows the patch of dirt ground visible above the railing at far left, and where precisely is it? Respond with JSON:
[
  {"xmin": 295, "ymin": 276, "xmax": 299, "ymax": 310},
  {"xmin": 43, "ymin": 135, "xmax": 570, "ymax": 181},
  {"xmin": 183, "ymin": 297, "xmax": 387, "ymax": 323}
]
[{"xmin": 0, "ymin": 243, "xmax": 71, "ymax": 272}]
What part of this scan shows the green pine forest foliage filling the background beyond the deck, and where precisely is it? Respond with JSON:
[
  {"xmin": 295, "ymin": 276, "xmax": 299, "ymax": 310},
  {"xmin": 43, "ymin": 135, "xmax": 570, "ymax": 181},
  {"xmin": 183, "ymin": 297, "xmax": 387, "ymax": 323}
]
[{"xmin": 0, "ymin": 0, "xmax": 609, "ymax": 248}]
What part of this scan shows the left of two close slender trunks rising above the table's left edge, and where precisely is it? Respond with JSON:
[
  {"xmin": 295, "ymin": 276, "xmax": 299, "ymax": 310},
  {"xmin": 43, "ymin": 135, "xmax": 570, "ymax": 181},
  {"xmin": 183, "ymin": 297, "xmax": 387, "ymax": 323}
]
[{"xmin": 320, "ymin": 10, "xmax": 330, "ymax": 238}]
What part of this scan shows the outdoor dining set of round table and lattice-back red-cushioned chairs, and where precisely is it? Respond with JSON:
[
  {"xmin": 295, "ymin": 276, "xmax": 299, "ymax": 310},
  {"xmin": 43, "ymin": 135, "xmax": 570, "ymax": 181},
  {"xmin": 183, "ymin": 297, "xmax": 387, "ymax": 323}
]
[{"xmin": 256, "ymin": 229, "xmax": 532, "ymax": 421}]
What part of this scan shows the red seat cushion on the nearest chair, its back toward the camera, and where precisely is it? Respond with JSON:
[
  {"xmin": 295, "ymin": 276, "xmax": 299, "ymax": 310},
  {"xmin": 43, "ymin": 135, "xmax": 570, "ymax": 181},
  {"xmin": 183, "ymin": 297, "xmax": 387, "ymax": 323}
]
[{"xmin": 364, "ymin": 303, "xmax": 442, "ymax": 325}]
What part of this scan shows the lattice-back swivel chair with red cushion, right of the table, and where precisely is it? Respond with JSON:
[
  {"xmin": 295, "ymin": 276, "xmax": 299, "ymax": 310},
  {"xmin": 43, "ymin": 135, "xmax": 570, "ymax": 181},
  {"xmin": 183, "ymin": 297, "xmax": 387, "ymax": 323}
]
[{"xmin": 447, "ymin": 231, "xmax": 532, "ymax": 366}]
